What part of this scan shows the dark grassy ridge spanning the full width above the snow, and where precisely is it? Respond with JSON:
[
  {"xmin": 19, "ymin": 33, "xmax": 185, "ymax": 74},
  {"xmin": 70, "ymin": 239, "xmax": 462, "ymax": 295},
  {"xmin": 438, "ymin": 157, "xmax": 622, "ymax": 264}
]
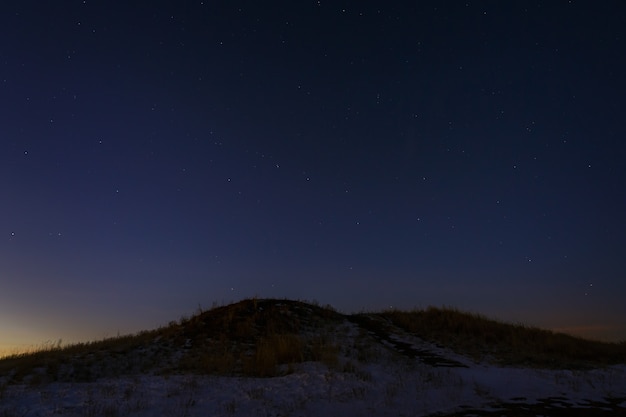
[{"xmin": 0, "ymin": 299, "xmax": 626, "ymax": 385}]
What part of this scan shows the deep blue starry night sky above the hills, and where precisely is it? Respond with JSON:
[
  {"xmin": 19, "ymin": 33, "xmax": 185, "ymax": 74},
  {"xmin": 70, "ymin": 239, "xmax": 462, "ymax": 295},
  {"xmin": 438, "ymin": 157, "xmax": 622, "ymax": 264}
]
[{"xmin": 0, "ymin": 0, "xmax": 626, "ymax": 350}]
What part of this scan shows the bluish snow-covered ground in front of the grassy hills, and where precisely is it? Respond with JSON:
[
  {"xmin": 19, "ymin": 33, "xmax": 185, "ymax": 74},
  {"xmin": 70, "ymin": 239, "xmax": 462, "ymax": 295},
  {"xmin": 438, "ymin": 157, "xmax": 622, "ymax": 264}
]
[{"xmin": 0, "ymin": 310, "xmax": 626, "ymax": 417}]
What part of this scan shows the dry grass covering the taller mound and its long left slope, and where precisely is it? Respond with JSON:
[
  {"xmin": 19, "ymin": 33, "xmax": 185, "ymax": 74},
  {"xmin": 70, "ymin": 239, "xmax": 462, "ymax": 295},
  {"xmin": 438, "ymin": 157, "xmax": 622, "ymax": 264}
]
[{"xmin": 0, "ymin": 299, "xmax": 341, "ymax": 385}]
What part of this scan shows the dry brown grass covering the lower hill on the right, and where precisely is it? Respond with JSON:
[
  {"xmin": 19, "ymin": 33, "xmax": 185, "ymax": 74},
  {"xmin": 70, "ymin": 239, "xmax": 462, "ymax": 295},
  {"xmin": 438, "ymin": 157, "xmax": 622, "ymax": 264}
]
[{"xmin": 381, "ymin": 307, "xmax": 626, "ymax": 368}]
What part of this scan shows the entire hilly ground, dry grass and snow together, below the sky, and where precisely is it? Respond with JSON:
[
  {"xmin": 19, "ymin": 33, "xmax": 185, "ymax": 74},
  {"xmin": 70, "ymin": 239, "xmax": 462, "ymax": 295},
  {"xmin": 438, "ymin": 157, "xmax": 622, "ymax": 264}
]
[{"xmin": 0, "ymin": 299, "xmax": 626, "ymax": 416}]
